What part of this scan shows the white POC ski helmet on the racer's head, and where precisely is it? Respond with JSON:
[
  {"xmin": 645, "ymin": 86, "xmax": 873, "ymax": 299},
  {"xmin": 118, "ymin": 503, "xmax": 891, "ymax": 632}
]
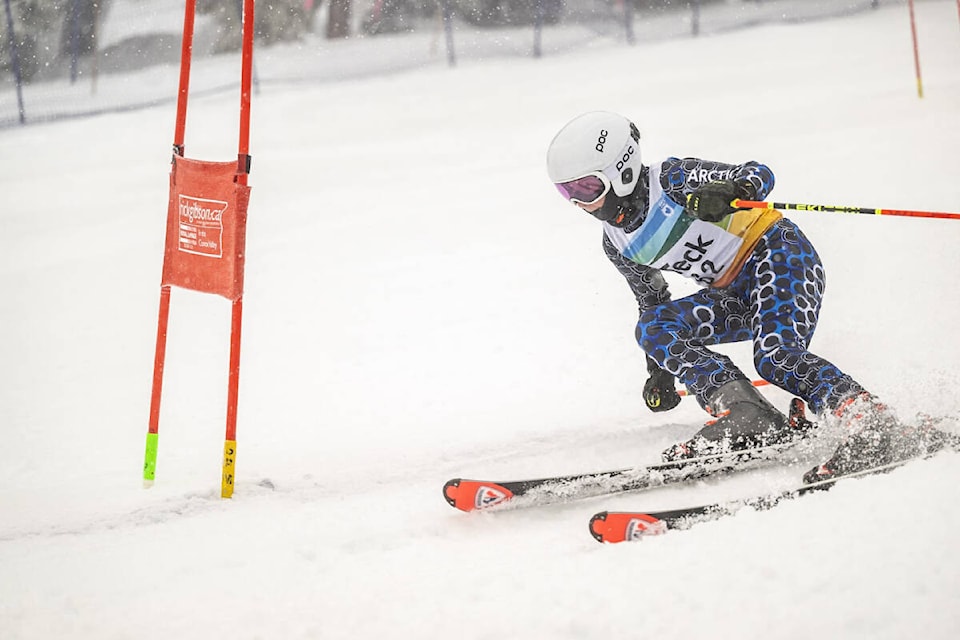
[{"xmin": 547, "ymin": 111, "xmax": 641, "ymax": 198}]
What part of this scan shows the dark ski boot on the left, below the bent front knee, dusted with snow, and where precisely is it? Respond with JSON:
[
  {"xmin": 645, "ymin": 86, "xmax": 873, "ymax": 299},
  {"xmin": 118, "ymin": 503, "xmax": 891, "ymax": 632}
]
[{"xmin": 662, "ymin": 380, "xmax": 813, "ymax": 462}]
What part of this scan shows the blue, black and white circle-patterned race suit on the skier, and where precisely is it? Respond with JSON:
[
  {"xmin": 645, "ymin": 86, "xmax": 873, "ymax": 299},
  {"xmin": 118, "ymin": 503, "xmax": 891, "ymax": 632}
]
[{"xmin": 604, "ymin": 158, "xmax": 863, "ymax": 414}]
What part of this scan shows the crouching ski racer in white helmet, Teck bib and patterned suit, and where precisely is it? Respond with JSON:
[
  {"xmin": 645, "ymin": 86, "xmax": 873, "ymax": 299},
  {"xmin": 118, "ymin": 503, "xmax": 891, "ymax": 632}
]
[{"xmin": 547, "ymin": 111, "xmax": 943, "ymax": 482}]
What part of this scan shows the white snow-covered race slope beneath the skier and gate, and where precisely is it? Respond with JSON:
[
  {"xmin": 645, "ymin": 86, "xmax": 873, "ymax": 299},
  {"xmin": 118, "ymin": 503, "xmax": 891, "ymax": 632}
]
[{"xmin": 0, "ymin": 0, "xmax": 960, "ymax": 640}]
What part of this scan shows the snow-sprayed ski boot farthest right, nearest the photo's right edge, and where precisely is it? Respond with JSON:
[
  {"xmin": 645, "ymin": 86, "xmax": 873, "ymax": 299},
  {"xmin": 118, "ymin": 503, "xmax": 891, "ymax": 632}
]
[{"xmin": 803, "ymin": 392, "xmax": 957, "ymax": 484}]
